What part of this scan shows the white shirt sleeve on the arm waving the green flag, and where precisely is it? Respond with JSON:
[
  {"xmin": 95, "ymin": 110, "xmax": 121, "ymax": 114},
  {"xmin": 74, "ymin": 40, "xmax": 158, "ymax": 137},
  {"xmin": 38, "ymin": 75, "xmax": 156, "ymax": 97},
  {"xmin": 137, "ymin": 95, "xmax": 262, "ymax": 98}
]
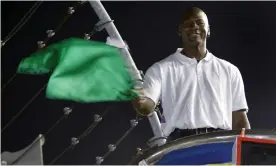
[{"xmin": 143, "ymin": 63, "xmax": 161, "ymax": 104}]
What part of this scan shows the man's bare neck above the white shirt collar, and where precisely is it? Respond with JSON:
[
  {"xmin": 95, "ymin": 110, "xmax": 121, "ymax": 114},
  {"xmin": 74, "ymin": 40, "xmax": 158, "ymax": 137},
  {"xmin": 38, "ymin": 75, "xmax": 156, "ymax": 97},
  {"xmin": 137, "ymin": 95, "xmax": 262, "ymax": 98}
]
[{"xmin": 181, "ymin": 45, "xmax": 207, "ymax": 60}]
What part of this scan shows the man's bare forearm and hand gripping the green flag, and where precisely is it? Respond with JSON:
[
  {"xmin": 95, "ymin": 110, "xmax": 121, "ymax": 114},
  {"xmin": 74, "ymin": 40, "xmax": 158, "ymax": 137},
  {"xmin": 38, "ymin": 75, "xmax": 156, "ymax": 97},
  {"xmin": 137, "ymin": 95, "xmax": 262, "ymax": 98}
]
[{"xmin": 132, "ymin": 86, "xmax": 155, "ymax": 116}]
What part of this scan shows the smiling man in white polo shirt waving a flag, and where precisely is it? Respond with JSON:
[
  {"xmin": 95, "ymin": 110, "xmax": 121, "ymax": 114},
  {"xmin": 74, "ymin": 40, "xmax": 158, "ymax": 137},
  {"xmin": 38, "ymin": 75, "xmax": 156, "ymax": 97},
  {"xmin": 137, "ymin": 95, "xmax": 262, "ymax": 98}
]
[{"xmin": 134, "ymin": 8, "xmax": 250, "ymax": 139}]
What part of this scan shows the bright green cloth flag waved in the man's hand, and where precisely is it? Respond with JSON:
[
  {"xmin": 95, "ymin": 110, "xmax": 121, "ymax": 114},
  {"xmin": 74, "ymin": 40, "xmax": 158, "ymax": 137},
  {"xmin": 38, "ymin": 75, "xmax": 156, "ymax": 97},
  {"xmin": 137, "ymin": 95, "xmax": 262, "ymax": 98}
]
[{"xmin": 17, "ymin": 38, "xmax": 137, "ymax": 103}]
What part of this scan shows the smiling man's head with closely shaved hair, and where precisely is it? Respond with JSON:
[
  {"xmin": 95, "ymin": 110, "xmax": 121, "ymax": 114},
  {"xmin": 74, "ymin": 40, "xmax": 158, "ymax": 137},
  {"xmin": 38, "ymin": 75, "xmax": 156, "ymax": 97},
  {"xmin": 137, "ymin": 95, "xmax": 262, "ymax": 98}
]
[{"xmin": 179, "ymin": 7, "xmax": 210, "ymax": 46}]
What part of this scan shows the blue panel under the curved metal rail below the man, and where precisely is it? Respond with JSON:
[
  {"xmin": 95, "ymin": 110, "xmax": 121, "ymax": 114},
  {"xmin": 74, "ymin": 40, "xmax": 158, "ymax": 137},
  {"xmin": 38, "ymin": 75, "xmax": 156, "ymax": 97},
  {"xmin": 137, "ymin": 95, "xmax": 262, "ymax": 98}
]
[{"xmin": 156, "ymin": 142, "xmax": 234, "ymax": 165}]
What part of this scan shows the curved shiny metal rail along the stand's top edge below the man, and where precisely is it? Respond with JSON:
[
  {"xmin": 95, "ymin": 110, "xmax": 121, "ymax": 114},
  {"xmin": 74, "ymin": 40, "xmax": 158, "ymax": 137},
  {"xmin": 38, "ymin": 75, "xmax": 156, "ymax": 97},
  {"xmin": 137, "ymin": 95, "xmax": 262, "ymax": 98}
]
[{"xmin": 129, "ymin": 130, "xmax": 276, "ymax": 165}]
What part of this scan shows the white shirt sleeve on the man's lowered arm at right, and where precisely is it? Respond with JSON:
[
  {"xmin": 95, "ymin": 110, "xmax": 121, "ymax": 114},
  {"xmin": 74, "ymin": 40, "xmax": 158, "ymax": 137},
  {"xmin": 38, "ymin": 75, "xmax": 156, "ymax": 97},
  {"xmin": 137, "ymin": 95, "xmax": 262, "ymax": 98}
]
[{"xmin": 231, "ymin": 67, "xmax": 248, "ymax": 111}]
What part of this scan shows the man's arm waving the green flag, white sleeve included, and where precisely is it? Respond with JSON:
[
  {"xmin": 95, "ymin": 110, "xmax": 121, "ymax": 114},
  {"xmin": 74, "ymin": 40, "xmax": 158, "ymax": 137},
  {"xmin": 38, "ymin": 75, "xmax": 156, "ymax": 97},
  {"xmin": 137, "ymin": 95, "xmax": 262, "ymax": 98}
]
[{"xmin": 133, "ymin": 64, "xmax": 161, "ymax": 115}]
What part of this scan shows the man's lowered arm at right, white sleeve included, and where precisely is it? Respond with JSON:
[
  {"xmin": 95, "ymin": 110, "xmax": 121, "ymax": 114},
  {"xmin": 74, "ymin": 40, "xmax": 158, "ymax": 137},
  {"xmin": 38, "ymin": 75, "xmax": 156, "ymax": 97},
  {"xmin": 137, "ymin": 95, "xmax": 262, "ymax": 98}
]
[{"xmin": 232, "ymin": 68, "xmax": 251, "ymax": 129}]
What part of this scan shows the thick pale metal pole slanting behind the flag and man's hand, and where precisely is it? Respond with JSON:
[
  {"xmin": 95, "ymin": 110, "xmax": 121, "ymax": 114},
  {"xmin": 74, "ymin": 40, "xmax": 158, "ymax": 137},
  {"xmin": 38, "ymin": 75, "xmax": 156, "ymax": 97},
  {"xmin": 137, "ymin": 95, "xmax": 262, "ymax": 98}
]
[{"xmin": 89, "ymin": 0, "xmax": 166, "ymax": 146}]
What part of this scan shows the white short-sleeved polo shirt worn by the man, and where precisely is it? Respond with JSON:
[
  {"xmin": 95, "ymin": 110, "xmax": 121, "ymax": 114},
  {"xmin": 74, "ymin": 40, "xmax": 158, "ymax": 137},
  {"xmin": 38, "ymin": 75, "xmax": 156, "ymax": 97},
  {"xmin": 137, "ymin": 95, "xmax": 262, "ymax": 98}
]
[{"xmin": 144, "ymin": 49, "xmax": 248, "ymax": 136}]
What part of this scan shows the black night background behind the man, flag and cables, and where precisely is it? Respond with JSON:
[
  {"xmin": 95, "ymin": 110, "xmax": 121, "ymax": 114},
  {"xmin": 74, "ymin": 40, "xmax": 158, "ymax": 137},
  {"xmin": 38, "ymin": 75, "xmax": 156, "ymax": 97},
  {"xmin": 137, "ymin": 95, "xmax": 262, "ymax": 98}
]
[{"xmin": 1, "ymin": 1, "xmax": 276, "ymax": 165}]
